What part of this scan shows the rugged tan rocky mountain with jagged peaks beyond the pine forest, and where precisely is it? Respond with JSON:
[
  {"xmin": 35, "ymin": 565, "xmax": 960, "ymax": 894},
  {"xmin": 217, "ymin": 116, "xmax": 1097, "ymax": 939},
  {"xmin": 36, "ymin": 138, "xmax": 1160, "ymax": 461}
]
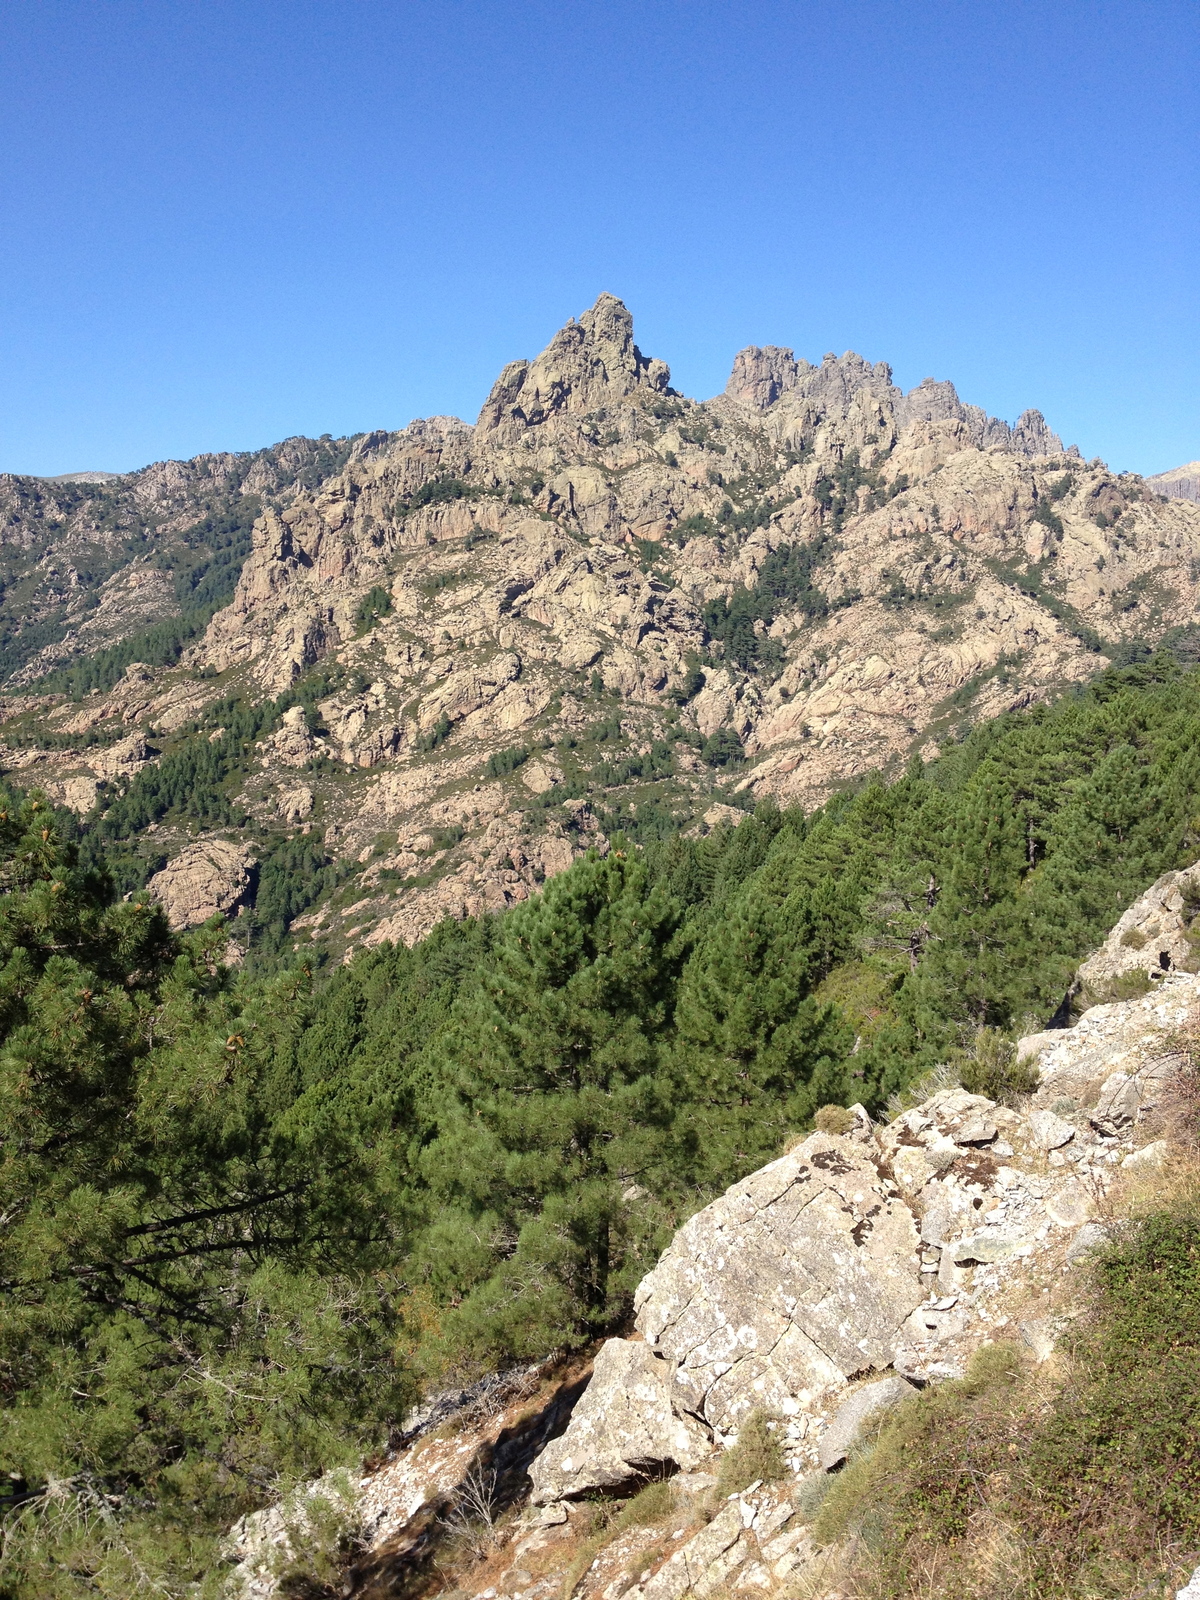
[{"xmin": 0, "ymin": 294, "xmax": 1200, "ymax": 958}]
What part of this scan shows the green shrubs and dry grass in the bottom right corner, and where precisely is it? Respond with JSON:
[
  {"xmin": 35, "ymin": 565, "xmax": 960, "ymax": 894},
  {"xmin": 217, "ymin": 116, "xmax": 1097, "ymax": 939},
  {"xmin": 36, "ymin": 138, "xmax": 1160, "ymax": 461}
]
[{"xmin": 814, "ymin": 1214, "xmax": 1200, "ymax": 1600}]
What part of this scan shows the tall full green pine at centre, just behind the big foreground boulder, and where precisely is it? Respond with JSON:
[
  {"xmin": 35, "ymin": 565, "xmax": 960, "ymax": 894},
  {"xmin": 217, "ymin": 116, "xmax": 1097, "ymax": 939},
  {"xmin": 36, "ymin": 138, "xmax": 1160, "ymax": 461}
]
[{"xmin": 421, "ymin": 848, "xmax": 686, "ymax": 1360}]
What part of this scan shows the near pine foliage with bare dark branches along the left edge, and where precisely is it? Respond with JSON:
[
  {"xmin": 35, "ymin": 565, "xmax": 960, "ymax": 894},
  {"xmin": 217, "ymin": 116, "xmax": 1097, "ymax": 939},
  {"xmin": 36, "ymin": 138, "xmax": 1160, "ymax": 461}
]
[{"xmin": 0, "ymin": 784, "xmax": 411, "ymax": 1600}]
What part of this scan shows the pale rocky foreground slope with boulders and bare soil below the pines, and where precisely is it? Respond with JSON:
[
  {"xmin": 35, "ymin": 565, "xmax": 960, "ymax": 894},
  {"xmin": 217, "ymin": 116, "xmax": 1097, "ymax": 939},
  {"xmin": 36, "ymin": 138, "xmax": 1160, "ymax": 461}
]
[{"xmin": 227, "ymin": 867, "xmax": 1200, "ymax": 1600}]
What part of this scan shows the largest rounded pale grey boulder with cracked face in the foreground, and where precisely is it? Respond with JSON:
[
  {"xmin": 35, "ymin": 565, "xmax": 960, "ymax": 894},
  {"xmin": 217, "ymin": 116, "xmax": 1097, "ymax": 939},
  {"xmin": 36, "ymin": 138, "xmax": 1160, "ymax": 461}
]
[{"xmin": 634, "ymin": 1133, "xmax": 923, "ymax": 1437}]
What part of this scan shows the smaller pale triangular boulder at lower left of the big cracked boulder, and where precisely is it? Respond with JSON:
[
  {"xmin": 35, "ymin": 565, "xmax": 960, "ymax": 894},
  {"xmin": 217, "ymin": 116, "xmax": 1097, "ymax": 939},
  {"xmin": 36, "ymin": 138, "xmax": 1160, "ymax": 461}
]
[{"xmin": 530, "ymin": 1339, "xmax": 712, "ymax": 1506}]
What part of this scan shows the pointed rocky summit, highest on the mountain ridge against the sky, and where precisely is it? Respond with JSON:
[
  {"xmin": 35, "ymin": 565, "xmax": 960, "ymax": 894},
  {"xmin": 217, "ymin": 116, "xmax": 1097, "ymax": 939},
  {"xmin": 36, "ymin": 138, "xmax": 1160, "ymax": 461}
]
[{"xmin": 478, "ymin": 294, "xmax": 670, "ymax": 440}]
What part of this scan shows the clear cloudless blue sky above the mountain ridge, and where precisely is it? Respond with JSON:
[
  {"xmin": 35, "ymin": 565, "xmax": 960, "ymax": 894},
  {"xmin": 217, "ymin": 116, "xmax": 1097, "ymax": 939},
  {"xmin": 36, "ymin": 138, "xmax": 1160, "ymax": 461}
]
[{"xmin": 0, "ymin": 0, "xmax": 1200, "ymax": 474}]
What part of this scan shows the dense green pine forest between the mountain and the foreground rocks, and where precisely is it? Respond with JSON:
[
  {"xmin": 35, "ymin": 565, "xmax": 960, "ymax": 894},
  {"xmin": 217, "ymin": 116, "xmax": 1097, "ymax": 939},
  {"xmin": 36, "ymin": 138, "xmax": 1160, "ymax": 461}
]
[{"xmin": 0, "ymin": 651, "xmax": 1200, "ymax": 1600}]
